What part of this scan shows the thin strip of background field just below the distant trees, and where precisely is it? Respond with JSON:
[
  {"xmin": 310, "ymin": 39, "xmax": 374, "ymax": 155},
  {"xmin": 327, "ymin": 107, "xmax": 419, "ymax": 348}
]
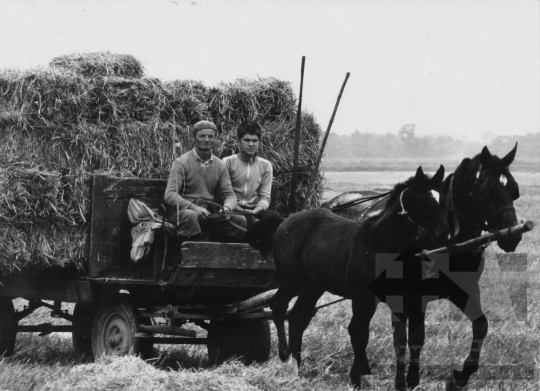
[{"xmin": 321, "ymin": 158, "xmax": 540, "ymax": 172}]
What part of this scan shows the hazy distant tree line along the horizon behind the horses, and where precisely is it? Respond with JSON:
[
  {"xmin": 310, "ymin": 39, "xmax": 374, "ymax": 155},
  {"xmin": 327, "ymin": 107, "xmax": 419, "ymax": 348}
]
[{"xmin": 325, "ymin": 124, "xmax": 540, "ymax": 159}]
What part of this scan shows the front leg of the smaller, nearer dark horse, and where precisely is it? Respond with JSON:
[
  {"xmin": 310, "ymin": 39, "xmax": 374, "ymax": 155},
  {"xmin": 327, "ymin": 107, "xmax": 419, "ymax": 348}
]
[{"xmin": 349, "ymin": 294, "xmax": 377, "ymax": 389}]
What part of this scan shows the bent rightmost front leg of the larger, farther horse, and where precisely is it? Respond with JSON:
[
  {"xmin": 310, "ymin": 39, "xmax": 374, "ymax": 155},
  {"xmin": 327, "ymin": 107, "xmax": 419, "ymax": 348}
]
[{"xmin": 447, "ymin": 283, "xmax": 488, "ymax": 390}]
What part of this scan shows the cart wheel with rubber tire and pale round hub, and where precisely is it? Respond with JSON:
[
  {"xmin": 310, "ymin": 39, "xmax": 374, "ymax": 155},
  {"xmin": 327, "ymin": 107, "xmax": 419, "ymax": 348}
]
[{"xmin": 92, "ymin": 299, "xmax": 152, "ymax": 358}]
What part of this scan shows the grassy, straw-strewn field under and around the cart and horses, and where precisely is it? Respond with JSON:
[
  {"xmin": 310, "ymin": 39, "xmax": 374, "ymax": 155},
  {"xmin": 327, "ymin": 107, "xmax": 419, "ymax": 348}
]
[{"xmin": 0, "ymin": 170, "xmax": 540, "ymax": 391}]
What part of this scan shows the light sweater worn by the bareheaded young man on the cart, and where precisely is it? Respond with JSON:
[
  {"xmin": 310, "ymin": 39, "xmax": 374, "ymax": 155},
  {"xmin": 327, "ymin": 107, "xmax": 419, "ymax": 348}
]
[{"xmin": 223, "ymin": 153, "xmax": 273, "ymax": 210}]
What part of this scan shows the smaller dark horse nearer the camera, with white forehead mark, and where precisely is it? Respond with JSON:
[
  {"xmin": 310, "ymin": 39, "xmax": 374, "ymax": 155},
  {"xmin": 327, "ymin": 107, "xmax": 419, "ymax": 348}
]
[{"xmin": 260, "ymin": 166, "xmax": 450, "ymax": 387}]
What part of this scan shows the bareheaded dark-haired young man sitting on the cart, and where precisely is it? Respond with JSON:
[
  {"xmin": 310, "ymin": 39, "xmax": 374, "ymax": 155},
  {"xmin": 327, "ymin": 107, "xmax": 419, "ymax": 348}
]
[{"xmin": 223, "ymin": 122, "xmax": 272, "ymax": 219}]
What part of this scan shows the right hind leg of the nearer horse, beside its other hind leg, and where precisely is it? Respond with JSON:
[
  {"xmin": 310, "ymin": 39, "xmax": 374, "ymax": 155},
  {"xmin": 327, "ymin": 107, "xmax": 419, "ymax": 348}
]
[{"xmin": 289, "ymin": 285, "xmax": 324, "ymax": 375}]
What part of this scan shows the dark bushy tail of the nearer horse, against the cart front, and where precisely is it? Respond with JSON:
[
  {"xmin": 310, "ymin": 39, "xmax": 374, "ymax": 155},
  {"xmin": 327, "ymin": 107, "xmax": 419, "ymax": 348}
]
[{"xmin": 244, "ymin": 211, "xmax": 285, "ymax": 259}]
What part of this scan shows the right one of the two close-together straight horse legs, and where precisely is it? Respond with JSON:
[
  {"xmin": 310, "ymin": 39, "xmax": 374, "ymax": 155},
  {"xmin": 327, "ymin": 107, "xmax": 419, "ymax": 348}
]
[{"xmin": 407, "ymin": 303, "xmax": 427, "ymax": 389}]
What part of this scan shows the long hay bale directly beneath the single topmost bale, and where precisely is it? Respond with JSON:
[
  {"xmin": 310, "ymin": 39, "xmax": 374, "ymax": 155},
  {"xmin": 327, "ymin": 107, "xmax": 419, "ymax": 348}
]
[{"xmin": 0, "ymin": 68, "xmax": 173, "ymax": 127}]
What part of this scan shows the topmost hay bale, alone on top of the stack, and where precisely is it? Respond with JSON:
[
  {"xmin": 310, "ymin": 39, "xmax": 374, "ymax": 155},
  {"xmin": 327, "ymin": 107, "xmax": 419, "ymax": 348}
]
[{"xmin": 49, "ymin": 52, "xmax": 144, "ymax": 78}]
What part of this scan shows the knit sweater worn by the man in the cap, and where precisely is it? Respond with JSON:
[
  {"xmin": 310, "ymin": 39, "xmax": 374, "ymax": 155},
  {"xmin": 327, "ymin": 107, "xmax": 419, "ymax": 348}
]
[{"xmin": 165, "ymin": 150, "xmax": 236, "ymax": 210}]
